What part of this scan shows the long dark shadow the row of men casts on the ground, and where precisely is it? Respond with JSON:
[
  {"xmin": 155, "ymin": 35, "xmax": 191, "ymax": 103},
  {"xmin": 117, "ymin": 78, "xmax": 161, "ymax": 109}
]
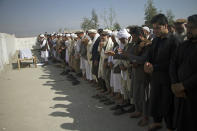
[{"xmin": 40, "ymin": 65, "xmax": 162, "ymax": 131}]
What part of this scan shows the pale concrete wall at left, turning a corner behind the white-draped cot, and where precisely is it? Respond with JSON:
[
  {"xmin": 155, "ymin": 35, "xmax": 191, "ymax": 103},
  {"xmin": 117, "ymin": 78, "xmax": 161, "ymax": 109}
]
[{"xmin": 0, "ymin": 33, "xmax": 39, "ymax": 72}]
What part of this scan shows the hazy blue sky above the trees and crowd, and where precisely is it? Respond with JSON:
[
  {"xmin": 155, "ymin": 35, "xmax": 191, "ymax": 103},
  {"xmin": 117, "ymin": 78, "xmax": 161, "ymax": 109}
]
[{"xmin": 0, "ymin": 0, "xmax": 197, "ymax": 37}]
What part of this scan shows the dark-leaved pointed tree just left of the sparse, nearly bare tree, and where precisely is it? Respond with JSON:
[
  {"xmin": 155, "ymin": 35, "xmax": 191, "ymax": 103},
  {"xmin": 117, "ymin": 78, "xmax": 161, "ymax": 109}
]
[{"xmin": 81, "ymin": 9, "xmax": 99, "ymax": 30}]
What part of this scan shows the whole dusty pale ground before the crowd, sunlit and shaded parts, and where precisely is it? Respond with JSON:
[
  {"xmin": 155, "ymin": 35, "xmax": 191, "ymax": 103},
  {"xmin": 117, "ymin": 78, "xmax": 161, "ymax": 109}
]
[{"xmin": 0, "ymin": 65, "xmax": 166, "ymax": 131}]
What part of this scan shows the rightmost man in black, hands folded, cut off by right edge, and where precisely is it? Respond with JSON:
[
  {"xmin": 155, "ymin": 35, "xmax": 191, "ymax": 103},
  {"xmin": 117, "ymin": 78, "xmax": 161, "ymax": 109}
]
[{"xmin": 170, "ymin": 15, "xmax": 197, "ymax": 131}]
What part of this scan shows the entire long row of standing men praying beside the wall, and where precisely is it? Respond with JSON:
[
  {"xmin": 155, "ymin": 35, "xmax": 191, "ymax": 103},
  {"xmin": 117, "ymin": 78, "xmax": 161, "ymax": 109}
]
[{"xmin": 38, "ymin": 14, "xmax": 197, "ymax": 131}]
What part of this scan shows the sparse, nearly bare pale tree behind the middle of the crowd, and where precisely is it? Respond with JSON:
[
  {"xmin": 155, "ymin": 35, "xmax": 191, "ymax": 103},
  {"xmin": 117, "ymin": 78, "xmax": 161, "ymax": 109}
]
[{"xmin": 101, "ymin": 8, "xmax": 116, "ymax": 29}]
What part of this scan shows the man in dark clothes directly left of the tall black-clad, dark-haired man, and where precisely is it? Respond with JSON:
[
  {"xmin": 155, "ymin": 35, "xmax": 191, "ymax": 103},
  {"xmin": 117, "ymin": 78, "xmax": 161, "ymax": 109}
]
[{"xmin": 129, "ymin": 27, "xmax": 151, "ymax": 126}]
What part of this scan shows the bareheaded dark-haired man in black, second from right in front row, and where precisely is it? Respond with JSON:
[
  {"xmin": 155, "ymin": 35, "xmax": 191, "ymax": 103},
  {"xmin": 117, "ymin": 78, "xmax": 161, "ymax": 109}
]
[{"xmin": 144, "ymin": 14, "xmax": 178, "ymax": 131}]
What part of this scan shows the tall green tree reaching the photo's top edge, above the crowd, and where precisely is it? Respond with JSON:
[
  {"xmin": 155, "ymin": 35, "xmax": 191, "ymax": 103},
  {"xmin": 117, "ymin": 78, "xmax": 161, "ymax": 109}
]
[{"xmin": 144, "ymin": 0, "xmax": 157, "ymax": 27}]
